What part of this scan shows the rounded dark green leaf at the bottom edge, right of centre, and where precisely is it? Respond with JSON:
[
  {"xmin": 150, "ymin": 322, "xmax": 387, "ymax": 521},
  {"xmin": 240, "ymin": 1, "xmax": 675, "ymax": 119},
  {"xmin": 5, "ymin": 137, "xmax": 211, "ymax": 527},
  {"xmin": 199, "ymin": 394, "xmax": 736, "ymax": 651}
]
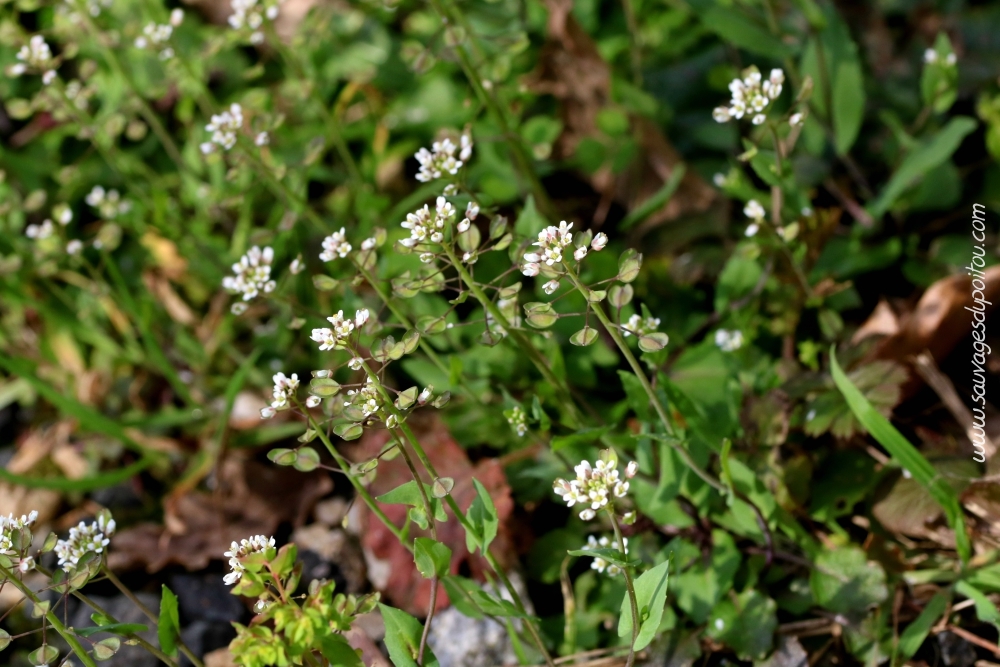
[{"xmin": 707, "ymin": 588, "xmax": 778, "ymax": 660}]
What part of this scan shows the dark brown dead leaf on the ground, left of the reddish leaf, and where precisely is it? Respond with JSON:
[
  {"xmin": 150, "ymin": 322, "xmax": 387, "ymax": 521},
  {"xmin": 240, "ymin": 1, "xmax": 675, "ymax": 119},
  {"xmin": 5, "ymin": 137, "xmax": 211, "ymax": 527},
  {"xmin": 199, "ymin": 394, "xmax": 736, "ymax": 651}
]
[{"xmin": 108, "ymin": 452, "xmax": 333, "ymax": 572}]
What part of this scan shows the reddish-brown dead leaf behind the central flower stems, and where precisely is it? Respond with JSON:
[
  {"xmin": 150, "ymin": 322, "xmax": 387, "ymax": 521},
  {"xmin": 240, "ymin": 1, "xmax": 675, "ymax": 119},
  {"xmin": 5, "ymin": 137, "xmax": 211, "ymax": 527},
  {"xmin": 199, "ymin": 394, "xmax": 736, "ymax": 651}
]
[{"xmin": 351, "ymin": 417, "xmax": 516, "ymax": 616}]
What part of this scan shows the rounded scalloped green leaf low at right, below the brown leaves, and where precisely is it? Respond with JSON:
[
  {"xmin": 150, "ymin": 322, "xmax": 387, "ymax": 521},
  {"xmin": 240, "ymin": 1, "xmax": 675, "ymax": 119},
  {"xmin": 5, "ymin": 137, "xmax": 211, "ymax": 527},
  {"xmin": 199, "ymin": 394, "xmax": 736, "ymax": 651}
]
[{"xmin": 809, "ymin": 546, "xmax": 889, "ymax": 614}]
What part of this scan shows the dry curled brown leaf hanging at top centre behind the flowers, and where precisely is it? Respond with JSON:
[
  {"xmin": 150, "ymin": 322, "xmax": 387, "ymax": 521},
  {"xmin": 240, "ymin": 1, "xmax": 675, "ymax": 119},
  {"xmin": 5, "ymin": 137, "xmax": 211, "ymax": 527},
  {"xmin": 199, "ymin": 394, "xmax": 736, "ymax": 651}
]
[{"xmin": 527, "ymin": 0, "xmax": 715, "ymax": 230}]
